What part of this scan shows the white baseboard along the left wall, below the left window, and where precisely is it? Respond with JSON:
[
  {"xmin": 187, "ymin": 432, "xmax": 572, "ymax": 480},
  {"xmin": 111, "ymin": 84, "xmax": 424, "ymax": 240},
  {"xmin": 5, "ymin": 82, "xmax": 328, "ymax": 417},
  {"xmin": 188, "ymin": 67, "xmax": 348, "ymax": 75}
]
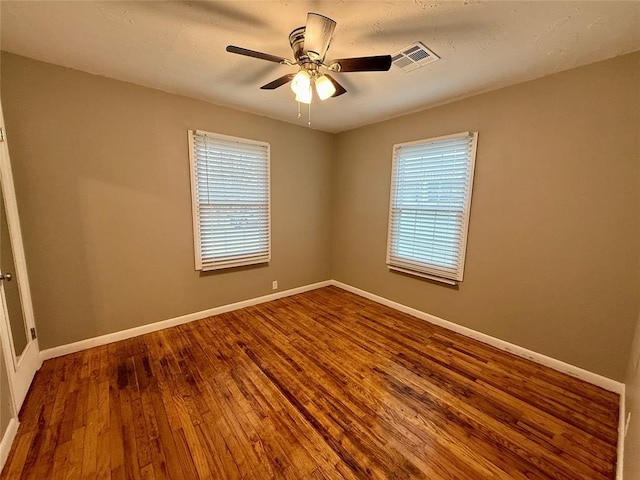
[{"xmin": 40, "ymin": 280, "xmax": 332, "ymax": 361}]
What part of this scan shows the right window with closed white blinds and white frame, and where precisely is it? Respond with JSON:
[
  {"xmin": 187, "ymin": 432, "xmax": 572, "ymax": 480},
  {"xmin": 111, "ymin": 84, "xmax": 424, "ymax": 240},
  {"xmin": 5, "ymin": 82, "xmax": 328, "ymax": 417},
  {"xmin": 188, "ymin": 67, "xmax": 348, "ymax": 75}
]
[{"xmin": 387, "ymin": 132, "xmax": 478, "ymax": 284}]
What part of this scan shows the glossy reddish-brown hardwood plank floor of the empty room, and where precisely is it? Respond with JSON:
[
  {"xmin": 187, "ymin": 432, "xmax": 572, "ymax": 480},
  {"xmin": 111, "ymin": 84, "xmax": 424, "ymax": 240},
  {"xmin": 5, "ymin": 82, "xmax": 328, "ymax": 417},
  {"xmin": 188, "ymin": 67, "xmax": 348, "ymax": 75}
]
[{"xmin": 0, "ymin": 287, "xmax": 618, "ymax": 480}]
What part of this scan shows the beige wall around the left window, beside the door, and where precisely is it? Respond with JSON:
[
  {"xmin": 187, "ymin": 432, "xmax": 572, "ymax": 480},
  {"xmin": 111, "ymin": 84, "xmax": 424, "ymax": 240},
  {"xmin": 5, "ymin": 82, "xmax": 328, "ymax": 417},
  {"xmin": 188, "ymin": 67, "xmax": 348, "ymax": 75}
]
[{"xmin": 2, "ymin": 53, "xmax": 333, "ymax": 348}]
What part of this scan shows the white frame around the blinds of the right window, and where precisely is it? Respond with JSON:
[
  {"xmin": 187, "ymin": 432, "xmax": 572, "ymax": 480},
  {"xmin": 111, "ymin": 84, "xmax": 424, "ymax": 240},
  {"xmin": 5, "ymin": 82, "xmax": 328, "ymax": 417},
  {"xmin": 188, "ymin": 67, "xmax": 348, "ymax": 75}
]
[{"xmin": 386, "ymin": 131, "xmax": 478, "ymax": 285}]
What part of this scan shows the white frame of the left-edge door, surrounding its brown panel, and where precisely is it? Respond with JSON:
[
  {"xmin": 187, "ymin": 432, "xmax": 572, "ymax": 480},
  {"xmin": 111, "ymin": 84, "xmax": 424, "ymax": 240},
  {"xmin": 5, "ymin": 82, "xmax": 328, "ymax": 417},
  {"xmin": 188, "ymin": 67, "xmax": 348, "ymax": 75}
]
[{"xmin": 0, "ymin": 102, "xmax": 42, "ymax": 416}]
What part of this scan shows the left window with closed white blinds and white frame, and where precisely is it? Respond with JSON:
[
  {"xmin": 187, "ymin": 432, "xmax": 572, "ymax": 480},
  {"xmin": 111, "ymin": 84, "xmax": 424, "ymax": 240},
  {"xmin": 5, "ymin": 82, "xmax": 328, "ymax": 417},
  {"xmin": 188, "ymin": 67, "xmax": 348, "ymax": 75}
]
[{"xmin": 189, "ymin": 130, "xmax": 271, "ymax": 270}]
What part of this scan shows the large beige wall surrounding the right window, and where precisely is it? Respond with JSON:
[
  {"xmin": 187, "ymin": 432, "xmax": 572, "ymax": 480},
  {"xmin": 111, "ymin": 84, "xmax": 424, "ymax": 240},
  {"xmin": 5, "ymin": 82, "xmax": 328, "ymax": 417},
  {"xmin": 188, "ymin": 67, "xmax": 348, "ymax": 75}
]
[{"xmin": 332, "ymin": 53, "xmax": 640, "ymax": 380}]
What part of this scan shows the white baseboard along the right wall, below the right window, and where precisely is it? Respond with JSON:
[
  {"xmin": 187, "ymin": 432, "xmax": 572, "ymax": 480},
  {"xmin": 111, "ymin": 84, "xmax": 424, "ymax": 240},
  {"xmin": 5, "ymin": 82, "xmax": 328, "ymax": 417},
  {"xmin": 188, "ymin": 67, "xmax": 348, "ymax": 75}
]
[{"xmin": 331, "ymin": 280, "xmax": 624, "ymax": 395}]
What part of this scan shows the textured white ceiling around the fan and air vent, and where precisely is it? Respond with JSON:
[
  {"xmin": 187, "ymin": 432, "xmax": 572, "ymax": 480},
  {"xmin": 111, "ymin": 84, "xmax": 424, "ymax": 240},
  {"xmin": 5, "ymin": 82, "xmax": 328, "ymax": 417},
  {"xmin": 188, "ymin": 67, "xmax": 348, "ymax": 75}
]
[{"xmin": 0, "ymin": 0, "xmax": 640, "ymax": 132}]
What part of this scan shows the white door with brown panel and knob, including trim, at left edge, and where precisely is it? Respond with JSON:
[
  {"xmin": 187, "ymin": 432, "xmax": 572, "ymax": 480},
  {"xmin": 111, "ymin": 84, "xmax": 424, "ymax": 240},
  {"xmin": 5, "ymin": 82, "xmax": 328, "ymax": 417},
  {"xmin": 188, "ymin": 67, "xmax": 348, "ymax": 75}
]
[{"xmin": 0, "ymin": 99, "xmax": 41, "ymax": 412}]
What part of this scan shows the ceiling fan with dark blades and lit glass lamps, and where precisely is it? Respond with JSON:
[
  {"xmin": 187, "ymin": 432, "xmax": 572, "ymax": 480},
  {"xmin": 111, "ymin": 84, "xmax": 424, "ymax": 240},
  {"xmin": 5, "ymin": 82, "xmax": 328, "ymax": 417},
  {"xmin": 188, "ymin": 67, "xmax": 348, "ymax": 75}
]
[{"xmin": 227, "ymin": 12, "xmax": 391, "ymax": 104}]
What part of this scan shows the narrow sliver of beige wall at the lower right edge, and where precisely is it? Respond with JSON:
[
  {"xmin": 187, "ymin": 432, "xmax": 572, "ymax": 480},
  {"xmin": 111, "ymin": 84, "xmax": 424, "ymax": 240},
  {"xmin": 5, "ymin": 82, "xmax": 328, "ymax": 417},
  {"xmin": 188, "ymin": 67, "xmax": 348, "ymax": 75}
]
[{"xmin": 624, "ymin": 310, "xmax": 640, "ymax": 479}]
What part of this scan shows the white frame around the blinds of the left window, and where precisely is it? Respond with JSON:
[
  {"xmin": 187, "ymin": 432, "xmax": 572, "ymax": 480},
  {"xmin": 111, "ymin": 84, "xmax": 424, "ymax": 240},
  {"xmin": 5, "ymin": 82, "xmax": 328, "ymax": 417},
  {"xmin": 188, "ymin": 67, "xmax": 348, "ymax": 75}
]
[{"xmin": 187, "ymin": 130, "xmax": 271, "ymax": 272}]
